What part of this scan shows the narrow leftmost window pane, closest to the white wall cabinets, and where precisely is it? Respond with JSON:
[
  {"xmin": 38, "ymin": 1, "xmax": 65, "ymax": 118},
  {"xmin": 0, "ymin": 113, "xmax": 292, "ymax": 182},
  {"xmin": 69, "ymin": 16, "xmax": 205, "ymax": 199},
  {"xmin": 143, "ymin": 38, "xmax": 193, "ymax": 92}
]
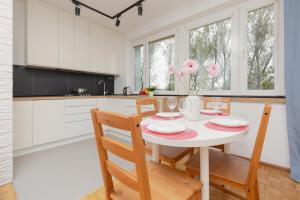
[{"xmin": 134, "ymin": 45, "xmax": 145, "ymax": 91}]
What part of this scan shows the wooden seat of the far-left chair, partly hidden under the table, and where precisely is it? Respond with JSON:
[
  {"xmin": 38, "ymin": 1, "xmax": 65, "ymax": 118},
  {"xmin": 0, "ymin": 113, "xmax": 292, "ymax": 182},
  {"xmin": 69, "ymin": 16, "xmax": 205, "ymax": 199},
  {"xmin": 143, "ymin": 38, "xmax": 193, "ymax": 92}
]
[{"xmin": 145, "ymin": 144, "xmax": 194, "ymax": 162}]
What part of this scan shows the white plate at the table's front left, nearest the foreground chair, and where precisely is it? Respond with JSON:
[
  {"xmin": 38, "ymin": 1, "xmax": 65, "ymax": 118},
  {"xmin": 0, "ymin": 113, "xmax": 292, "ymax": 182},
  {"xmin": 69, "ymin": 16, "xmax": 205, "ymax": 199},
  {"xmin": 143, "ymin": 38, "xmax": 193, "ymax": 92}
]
[{"xmin": 147, "ymin": 123, "xmax": 186, "ymax": 134}]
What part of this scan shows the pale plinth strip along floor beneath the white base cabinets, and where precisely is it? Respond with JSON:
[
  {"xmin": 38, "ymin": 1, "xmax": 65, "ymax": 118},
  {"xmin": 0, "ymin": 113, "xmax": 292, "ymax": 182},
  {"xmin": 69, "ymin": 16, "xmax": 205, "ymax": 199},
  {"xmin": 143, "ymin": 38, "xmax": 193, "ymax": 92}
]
[{"xmin": 13, "ymin": 133, "xmax": 94, "ymax": 157}]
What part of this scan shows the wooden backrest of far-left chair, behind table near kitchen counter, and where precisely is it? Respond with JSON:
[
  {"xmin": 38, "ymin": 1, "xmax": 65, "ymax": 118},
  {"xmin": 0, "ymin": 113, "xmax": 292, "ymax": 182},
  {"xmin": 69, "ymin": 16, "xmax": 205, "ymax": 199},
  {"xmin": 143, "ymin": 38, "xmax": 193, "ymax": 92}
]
[{"xmin": 136, "ymin": 98, "xmax": 159, "ymax": 118}]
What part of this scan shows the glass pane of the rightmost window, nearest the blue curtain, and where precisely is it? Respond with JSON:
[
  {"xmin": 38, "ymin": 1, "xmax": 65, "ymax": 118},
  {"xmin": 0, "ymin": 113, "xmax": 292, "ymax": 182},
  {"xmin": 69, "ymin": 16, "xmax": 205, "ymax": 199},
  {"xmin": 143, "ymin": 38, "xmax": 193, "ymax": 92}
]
[{"xmin": 247, "ymin": 4, "xmax": 276, "ymax": 90}]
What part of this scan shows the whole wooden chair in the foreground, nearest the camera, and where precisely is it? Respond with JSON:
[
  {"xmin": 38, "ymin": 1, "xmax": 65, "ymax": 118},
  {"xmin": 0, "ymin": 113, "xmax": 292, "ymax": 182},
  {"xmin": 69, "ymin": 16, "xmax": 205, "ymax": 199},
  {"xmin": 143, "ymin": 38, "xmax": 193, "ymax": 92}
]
[{"xmin": 88, "ymin": 108, "xmax": 202, "ymax": 200}]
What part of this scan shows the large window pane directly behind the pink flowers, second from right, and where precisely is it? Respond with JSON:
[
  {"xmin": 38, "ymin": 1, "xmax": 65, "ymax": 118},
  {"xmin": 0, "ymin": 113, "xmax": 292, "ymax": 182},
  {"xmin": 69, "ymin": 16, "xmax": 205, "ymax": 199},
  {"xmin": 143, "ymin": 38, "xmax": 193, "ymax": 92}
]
[{"xmin": 189, "ymin": 18, "xmax": 232, "ymax": 90}]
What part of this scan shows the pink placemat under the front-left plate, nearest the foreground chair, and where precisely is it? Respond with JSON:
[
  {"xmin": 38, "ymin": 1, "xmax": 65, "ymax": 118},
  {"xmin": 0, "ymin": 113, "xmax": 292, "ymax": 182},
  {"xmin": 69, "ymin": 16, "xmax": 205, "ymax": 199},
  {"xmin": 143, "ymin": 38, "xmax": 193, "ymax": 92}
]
[{"xmin": 142, "ymin": 125, "xmax": 198, "ymax": 140}]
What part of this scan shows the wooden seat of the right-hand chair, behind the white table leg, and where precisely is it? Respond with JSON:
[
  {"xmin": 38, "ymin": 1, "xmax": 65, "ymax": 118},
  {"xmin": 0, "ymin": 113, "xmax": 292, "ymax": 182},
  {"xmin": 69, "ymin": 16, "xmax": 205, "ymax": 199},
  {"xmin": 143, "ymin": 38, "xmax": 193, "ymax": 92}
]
[{"xmin": 186, "ymin": 149, "xmax": 250, "ymax": 185}]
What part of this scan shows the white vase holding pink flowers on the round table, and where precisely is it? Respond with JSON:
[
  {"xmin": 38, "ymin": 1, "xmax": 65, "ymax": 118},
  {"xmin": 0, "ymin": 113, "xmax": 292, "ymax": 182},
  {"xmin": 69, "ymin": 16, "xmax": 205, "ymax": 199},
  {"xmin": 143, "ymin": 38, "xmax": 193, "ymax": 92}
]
[{"xmin": 185, "ymin": 96, "xmax": 201, "ymax": 121}]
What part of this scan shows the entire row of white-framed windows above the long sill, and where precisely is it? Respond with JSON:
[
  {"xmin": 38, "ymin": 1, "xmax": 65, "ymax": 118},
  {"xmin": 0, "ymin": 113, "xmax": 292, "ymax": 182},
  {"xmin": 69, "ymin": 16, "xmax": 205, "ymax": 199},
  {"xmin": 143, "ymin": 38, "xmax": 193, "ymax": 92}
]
[{"xmin": 134, "ymin": 0, "xmax": 284, "ymax": 96}]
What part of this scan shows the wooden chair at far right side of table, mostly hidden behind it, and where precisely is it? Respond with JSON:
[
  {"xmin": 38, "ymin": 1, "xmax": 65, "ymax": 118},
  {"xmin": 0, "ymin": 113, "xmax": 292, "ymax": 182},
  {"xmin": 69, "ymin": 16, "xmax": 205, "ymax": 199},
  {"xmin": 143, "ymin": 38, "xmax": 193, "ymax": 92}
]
[{"xmin": 203, "ymin": 97, "xmax": 231, "ymax": 152}]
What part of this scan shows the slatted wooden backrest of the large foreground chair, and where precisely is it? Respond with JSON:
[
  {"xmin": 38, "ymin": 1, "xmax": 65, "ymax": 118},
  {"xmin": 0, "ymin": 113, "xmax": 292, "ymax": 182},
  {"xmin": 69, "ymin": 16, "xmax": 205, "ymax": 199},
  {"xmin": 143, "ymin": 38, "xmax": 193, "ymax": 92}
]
[{"xmin": 91, "ymin": 108, "xmax": 151, "ymax": 200}]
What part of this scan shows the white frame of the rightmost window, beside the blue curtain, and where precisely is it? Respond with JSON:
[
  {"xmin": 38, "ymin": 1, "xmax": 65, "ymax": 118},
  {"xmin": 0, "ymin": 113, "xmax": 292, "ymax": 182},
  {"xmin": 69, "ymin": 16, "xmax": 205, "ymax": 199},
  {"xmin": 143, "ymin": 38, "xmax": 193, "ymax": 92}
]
[{"xmin": 239, "ymin": 0, "xmax": 285, "ymax": 96}]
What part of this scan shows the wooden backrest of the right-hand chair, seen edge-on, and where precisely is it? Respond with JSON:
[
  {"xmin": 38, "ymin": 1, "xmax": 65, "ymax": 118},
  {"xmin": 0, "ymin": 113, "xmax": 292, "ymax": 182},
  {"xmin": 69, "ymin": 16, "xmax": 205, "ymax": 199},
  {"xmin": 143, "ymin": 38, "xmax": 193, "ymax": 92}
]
[{"xmin": 247, "ymin": 104, "xmax": 272, "ymax": 187}]
